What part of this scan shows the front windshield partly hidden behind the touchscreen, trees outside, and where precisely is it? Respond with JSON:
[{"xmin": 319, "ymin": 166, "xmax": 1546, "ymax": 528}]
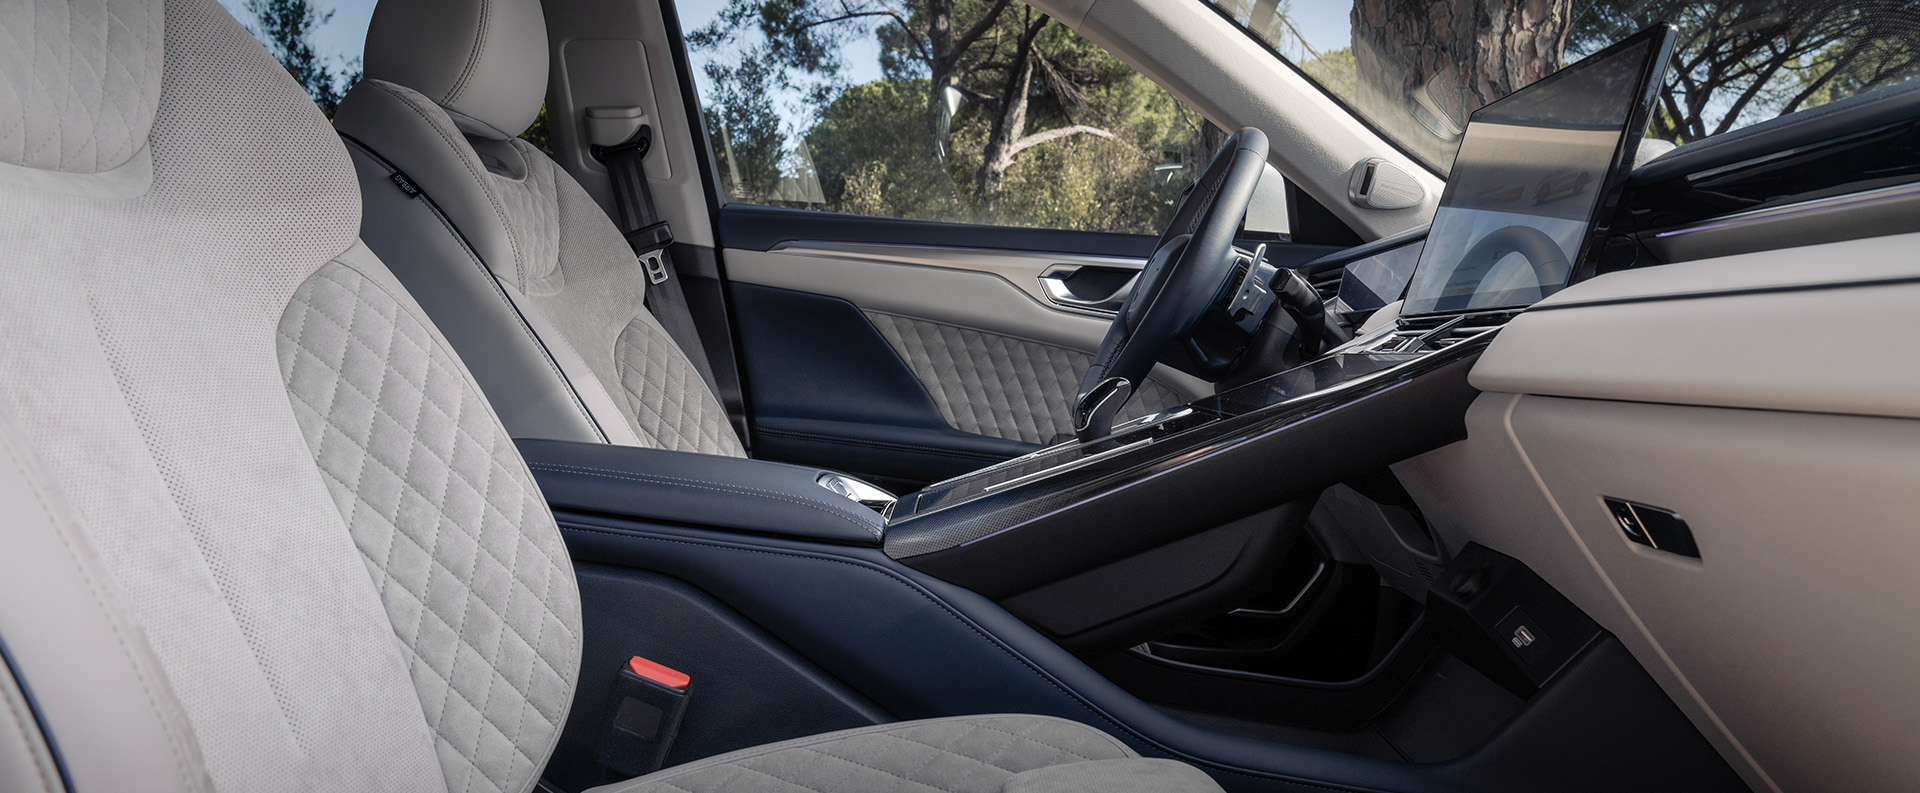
[{"xmin": 1200, "ymin": 0, "xmax": 1920, "ymax": 175}]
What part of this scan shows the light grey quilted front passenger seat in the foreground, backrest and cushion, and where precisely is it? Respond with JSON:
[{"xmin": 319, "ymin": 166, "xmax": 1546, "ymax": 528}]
[{"xmin": 0, "ymin": 0, "xmax": 1212, "ymax": 793}]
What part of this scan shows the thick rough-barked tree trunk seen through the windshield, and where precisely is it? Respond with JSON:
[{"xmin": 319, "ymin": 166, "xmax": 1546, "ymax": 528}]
[{"xmin": 1350, "ymin": 0, "xmax": 1572, "ymax": 161}]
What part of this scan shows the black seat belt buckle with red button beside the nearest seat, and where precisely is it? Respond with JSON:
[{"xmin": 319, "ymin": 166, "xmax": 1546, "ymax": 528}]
[{"xmin": 593, "ymin": 655, "xmax": 693, "ymax": 776}]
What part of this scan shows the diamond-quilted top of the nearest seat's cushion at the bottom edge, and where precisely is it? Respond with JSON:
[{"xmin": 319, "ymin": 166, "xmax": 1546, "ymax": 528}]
[{"xmin": 618, "ymin": 716, "xmax": 1129, "ymax": 793}]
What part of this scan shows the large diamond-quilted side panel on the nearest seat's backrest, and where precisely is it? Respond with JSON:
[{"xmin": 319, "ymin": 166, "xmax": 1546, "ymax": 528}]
[{"xmin": 280, "ymin": 263, "xmax": 580, "ymax": 791}]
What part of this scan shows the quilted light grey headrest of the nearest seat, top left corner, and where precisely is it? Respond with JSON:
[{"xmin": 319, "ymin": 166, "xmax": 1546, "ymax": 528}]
[{"xmin": 0, "ymin": 0, "xmax": 163, "ymax": 173}]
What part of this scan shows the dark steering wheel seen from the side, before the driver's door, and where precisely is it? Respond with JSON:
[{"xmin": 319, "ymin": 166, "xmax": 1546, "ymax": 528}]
[{"xmin": 1073, "ymin": 127, "xmax": 1267, "ymax": 440}]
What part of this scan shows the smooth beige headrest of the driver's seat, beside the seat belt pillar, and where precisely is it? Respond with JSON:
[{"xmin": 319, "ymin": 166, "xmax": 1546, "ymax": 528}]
[{"xmin": 365, "ymin": 0, "xmax": 547, "ymax": 140}]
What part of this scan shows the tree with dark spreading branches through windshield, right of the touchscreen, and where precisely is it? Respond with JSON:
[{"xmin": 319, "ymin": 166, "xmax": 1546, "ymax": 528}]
[{"xmin": 1576, "ymin": 0, "xmax": 1920, "ymax": 142}]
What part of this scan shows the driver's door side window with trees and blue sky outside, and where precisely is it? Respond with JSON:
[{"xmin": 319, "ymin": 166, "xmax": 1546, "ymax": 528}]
[{"xmin": 676, "ymin": 0, "xmax": 1286, "ymax": 234}]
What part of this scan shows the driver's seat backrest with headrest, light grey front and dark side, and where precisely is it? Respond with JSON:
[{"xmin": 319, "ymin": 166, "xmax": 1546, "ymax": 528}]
[{"xmin": 334, "ymin": 0, "xmax": 745, "ymax": 457}]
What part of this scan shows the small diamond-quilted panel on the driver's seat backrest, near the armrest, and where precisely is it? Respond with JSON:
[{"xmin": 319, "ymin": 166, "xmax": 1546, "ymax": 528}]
[{"xmin": 612, "ymin": 317, "xmax": 747, "ymax": 457}]
